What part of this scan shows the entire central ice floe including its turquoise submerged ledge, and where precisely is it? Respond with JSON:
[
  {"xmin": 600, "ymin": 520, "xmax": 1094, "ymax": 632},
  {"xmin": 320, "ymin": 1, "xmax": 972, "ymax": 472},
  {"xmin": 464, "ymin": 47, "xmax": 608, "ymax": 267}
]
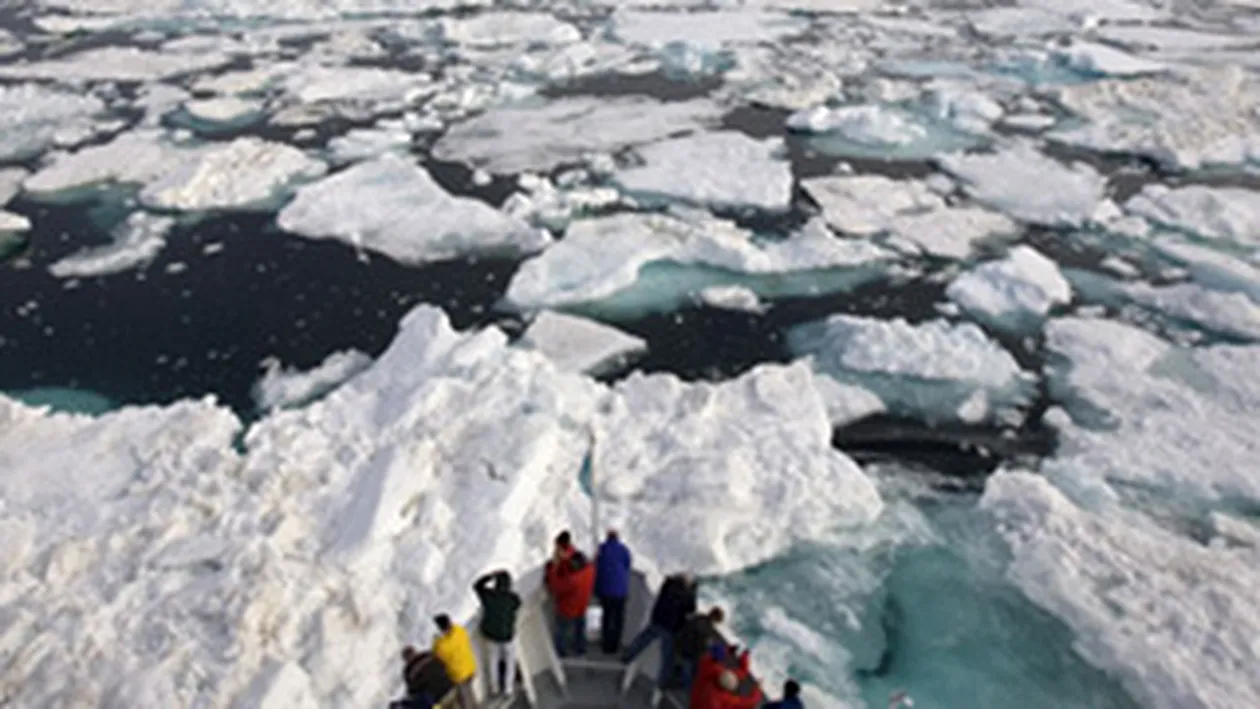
[{"xmin": 505, "ymin": 213, "xmax": 892, "ymax": 319}]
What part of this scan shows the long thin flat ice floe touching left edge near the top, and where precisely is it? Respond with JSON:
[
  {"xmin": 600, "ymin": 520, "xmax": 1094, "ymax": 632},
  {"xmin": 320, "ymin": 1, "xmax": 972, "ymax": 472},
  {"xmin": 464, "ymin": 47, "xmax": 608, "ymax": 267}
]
[{"xmin": 0, "ymin": 47, "xmax": 232, "ymax": 83}]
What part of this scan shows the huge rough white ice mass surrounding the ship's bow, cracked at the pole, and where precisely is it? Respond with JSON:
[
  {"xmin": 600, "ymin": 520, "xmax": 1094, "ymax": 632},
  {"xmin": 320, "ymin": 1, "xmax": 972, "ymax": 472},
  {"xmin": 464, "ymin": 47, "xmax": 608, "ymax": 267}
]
[{"xmin": 0, "ymin": 306, "xmax": 882, "ymax": 708}]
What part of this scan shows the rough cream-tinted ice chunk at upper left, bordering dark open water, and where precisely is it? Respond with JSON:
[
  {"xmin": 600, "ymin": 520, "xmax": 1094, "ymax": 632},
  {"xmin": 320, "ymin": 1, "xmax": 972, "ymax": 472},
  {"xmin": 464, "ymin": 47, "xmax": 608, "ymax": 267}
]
[{"xmin": 140, "ymin": 136, "xmax": 326, "ymax": 212}]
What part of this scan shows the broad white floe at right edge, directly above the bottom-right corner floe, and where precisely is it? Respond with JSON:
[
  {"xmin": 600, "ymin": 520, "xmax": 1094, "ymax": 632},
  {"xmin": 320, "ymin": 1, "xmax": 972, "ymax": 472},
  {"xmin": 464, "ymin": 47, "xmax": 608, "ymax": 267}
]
[{"xmin": 1046, "ymin": 317, "xmax": 1260, "ymax": 500}]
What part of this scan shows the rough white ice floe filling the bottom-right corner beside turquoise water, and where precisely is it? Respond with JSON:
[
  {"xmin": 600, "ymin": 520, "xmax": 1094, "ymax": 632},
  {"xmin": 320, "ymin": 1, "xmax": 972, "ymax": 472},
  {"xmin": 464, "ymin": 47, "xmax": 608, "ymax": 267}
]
[{"xmin": 980, "ymin": 472, "xmax": 1260, "ymax": 709}]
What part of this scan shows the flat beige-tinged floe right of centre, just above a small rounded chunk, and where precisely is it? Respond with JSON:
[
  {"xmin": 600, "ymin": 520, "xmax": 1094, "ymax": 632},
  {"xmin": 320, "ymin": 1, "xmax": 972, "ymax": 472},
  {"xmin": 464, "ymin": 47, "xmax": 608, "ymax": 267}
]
[{"xmin": 801, "ymin": 175, "xmax": 1019, "ymax": 259}]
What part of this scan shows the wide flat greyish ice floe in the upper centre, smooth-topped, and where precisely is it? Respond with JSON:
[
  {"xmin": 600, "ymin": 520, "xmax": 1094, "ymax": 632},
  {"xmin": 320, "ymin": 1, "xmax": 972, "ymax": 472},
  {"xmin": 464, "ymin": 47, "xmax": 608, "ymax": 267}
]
[{"xmin": 433, "ymin": 97, "xmax": 722, "ymax": 174}]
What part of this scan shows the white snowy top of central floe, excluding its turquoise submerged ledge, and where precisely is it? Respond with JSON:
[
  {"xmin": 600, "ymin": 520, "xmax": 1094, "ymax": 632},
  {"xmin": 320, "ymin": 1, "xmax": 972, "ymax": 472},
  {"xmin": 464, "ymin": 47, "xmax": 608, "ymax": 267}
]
[{"xmin": 505, "ymin": 213, "xmax": 891, "ymax": 310}]
